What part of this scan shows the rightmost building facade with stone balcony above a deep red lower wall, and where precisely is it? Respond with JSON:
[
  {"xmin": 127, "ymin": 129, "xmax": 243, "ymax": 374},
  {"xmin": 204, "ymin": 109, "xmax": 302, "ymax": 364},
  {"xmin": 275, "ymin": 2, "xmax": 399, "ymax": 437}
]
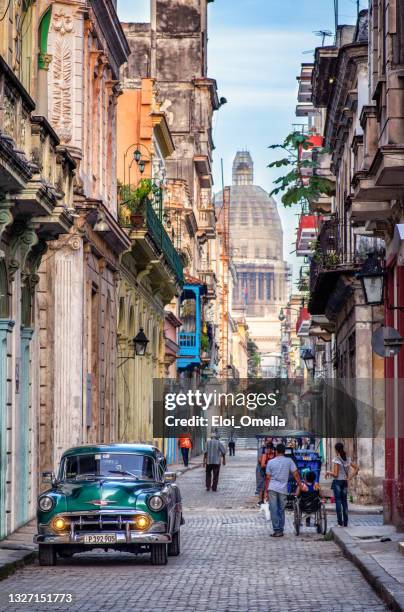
[{"xmin": 352, "ymin": 0, "xmax": 404, "ymax": 528}]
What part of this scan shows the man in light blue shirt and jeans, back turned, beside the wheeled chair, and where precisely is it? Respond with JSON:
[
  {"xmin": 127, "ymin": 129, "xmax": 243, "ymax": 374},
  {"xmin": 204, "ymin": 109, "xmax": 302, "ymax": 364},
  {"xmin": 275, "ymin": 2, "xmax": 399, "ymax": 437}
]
[{"xmin": 266, "ymin": 444, "xmax": 301, "ymax": 538}]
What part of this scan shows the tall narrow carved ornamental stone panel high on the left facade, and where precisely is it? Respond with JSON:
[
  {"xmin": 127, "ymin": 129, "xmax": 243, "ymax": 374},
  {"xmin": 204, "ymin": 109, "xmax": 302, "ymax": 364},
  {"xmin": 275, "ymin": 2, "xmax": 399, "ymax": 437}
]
[{"xmin": 52, "ymin": 39, "xmax": 73, "ymax": 143}]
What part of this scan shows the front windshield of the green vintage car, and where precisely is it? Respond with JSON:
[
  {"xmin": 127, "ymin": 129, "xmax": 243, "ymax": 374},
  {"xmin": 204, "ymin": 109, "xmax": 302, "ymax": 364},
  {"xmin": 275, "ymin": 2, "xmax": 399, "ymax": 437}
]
[{"xmin": 61, "ymin": 453, "xmax": 154, "ymax": 480}]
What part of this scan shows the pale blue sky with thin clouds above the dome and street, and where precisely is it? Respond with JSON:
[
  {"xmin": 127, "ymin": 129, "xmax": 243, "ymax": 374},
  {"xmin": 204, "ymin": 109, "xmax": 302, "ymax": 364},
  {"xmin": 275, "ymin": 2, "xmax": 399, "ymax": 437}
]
[{"xmin": 118, "ymin": 0, "xmax": 367, "ymax": 275}]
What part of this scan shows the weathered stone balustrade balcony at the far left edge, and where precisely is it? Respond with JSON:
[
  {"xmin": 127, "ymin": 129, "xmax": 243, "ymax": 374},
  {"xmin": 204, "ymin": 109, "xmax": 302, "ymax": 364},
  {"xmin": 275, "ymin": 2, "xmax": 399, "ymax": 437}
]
[{"xmin": 0, "ymin": 57, "xmax": 76, "ymax": 240}]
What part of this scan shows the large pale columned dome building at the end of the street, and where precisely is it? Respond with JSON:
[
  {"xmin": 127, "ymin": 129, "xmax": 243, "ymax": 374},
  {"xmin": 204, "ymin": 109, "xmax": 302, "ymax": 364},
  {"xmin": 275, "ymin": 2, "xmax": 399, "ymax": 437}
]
[{"xmin": 215, "ymin": 151, "xmax": 289, "ymax": 366}]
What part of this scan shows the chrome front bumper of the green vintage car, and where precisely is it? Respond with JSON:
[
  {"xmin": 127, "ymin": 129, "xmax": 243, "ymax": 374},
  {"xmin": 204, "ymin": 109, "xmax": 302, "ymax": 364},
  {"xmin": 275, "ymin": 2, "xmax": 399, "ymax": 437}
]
[{"xmin": 34, "ymin": 531, "xmax": 172, "ymax": 548}]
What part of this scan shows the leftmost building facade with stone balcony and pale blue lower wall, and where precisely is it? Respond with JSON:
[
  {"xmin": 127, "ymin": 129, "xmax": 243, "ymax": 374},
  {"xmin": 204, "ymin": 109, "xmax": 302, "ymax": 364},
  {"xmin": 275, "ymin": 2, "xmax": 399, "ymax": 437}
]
[{"xmin": 0, "ymin": 2, "xmax": 76, "ymax": 538}]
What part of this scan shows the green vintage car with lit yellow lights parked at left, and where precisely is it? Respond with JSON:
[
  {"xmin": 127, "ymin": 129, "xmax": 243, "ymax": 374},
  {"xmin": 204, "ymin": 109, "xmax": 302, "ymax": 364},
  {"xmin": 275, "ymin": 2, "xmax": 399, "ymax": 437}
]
[{"xmin": 34, "ymin": 444, "xmax": 183, "ymax": 565}]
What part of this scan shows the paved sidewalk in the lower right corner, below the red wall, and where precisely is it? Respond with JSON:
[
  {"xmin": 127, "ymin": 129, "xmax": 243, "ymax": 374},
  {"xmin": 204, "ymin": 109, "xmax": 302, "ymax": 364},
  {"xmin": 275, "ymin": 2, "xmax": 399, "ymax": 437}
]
[{"xmin": 332, "ymin": 525, "xmax": 404, "ymax": 610}]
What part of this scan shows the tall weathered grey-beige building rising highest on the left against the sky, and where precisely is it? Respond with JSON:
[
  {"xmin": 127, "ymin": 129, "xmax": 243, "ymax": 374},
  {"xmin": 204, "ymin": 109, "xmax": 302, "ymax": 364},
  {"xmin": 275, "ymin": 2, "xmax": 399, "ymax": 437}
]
[{"xmin": 124, "ymin": 0, "xmax": 220, "ymax": 372}]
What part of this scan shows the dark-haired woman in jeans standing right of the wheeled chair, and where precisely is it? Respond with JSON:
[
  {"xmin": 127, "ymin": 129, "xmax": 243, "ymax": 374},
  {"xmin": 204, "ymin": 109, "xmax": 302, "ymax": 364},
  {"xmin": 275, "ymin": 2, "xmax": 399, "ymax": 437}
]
[{"xmin": 325, "ymin": 442, "xmax": 359, "ymax": 527}]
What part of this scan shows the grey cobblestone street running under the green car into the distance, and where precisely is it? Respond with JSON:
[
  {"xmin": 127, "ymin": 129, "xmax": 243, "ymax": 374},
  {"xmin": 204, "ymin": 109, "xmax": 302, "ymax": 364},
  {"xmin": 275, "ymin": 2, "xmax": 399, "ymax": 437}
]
[{"xmin": 0, "ymin": 451, "xmax": 386, "ymax": 612}]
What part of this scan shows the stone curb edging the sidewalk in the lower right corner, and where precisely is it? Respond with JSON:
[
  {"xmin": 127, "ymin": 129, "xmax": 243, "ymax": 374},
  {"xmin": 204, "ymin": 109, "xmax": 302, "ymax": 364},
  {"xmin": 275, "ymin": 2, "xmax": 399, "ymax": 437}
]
[{"xmin": 332, "ymin": 528, "xmax": 404, "ymax": 612}]
